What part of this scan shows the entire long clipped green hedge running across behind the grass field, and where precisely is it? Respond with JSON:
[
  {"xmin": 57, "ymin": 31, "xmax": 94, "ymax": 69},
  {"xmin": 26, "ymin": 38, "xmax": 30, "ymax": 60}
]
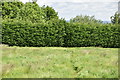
[{"xmin": 2, "ymin": 20, "xmax": 120, "ymax": 48}]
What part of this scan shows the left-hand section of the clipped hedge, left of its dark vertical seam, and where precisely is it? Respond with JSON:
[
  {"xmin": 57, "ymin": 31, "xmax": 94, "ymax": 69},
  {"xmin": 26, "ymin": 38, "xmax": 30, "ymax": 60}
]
[{"xmin": 2, "ymin": 20, "xmax": 65, "ymax": 46}]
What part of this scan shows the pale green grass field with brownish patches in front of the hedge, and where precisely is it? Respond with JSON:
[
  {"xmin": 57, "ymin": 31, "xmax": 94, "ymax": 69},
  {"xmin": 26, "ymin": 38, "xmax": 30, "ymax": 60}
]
[{"xmin": 2, "ymin": 46, "xmax": 118, "ymax": 78}]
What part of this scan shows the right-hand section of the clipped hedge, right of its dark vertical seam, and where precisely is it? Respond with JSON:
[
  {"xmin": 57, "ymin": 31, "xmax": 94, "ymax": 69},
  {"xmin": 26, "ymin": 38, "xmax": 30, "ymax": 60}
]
[{"xmin": 65, "ymin": 24, "xmax": 120, "ymax": 48}]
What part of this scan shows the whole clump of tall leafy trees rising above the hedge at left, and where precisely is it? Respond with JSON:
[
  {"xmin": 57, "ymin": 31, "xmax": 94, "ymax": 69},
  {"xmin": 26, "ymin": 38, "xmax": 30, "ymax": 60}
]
[{"xmin": 2, "ymin": 2, "xmax": 58, "ymax": 23}]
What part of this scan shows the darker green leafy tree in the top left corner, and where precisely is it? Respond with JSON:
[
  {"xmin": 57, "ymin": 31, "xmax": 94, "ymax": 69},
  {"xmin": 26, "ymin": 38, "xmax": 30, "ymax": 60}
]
[{"xmin": 2, "ymin": 2, "xmax": 24, "ymax": 19}]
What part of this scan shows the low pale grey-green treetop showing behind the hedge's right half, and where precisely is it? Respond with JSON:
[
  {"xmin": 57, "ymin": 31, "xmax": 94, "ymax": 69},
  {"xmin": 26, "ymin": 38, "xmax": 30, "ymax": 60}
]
[{"xmin": 70, "ymin": 15, "xmax": 102, "ymax": 23}]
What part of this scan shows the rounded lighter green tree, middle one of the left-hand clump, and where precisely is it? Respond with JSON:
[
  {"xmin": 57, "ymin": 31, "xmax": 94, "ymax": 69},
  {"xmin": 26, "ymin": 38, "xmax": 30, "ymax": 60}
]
[{"xmin": 18, "ymin": 2, "xmax": 45, "ymax": 23}]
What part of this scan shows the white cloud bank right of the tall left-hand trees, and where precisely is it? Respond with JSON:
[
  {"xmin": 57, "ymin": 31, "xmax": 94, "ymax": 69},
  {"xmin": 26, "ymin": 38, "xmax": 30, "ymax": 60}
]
[{"xmin": 51, "ymin": 2, "xmax": 117, "ymax": 21}]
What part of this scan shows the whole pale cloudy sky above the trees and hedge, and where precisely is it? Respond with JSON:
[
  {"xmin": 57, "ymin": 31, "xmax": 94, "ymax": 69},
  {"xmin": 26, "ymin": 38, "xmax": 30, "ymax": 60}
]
[{"xmin": 20, "ymin": 0, "xmax": 119, "ymax": 21}]
